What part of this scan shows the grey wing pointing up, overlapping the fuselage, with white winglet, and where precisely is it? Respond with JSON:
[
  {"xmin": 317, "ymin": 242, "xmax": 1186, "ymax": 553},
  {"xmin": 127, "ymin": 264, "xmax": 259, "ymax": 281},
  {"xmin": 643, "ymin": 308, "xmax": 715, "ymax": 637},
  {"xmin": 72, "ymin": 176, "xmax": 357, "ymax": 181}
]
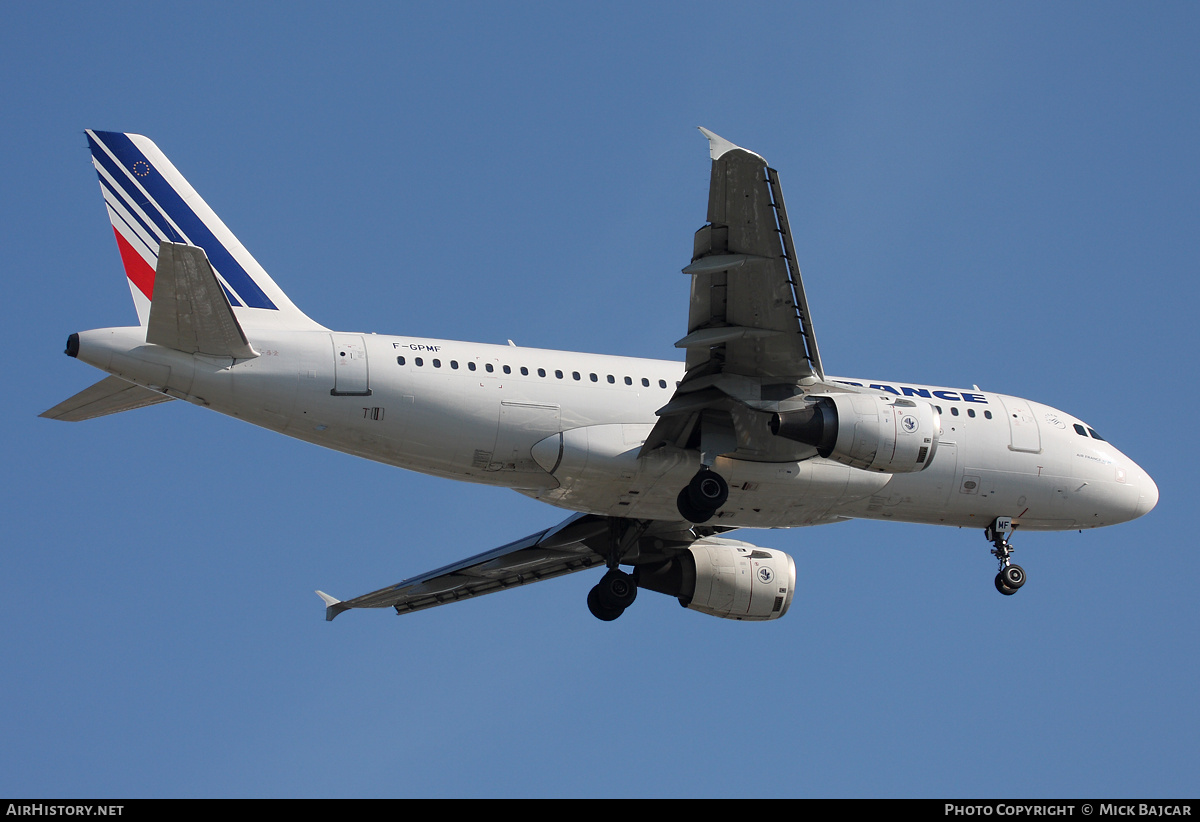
[{"xmin": 642, "ymin": 128, "xmax": 846, "ymax": 454}]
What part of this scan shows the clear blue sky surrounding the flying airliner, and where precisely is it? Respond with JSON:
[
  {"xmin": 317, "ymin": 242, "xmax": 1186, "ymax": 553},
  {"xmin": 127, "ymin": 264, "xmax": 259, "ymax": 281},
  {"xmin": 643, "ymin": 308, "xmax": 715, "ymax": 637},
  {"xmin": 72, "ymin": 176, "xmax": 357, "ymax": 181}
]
[{"xmin": 0, "ymin": 2, "xmax": 1200, "ymax": 797}]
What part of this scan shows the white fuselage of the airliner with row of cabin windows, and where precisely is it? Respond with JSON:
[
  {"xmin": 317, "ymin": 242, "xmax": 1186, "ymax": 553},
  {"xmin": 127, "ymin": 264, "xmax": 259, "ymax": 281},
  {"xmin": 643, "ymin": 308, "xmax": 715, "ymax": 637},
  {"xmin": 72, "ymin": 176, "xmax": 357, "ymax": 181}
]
[{"xmin": 78, "ymin": 328, "xmax": 1158, "ymax": 530}]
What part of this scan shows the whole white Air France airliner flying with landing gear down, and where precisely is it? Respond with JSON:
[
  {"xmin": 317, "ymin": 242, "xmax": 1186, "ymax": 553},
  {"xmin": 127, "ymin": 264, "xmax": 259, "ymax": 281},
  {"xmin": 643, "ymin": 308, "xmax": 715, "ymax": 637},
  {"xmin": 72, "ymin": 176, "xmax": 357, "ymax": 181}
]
[{"xmin": 42, "ymin": 128, "xmax": 1158, "ymax": 620}]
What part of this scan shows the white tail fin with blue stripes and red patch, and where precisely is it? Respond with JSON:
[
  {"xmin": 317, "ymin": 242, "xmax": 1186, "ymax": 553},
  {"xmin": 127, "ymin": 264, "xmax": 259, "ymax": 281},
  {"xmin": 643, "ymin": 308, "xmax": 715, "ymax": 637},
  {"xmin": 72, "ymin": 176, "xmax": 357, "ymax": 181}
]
[{"xmin": 86, "ymin": 130, "xmax": 323, "ymax": 330}]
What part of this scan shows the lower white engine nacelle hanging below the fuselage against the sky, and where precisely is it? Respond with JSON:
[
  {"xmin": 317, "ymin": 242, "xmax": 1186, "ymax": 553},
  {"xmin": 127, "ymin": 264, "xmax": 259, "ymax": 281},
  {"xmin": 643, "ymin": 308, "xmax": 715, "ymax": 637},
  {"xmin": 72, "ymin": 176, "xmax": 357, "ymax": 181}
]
[{"xmin": 637, "ymin": 538, "xmax": 796, "ymax": 622}]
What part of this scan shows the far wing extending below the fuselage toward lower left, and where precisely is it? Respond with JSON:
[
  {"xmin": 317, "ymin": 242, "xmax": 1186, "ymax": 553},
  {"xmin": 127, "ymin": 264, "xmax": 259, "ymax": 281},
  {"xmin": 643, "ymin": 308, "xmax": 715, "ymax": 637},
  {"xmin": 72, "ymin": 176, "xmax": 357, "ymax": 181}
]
[{"xmin": 317, "ymin": 514, "xmax": 732, "ymax": 620}]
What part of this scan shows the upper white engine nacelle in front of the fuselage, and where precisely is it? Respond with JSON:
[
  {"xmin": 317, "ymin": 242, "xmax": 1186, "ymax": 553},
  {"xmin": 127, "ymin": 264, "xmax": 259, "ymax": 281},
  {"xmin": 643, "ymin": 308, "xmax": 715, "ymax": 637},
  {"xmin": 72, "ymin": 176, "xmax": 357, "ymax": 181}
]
[{"xmin": 770, "ymin": 394, "xmax": 942, "ymax": 474}]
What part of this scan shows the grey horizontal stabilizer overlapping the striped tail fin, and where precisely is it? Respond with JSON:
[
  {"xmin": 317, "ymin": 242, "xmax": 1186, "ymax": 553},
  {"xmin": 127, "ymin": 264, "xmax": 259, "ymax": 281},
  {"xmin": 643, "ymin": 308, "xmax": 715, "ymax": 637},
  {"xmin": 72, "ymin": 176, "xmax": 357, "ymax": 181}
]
[{"xmin": 146, "ymin": 242, "xmax": 258, "ymax": 360}]
